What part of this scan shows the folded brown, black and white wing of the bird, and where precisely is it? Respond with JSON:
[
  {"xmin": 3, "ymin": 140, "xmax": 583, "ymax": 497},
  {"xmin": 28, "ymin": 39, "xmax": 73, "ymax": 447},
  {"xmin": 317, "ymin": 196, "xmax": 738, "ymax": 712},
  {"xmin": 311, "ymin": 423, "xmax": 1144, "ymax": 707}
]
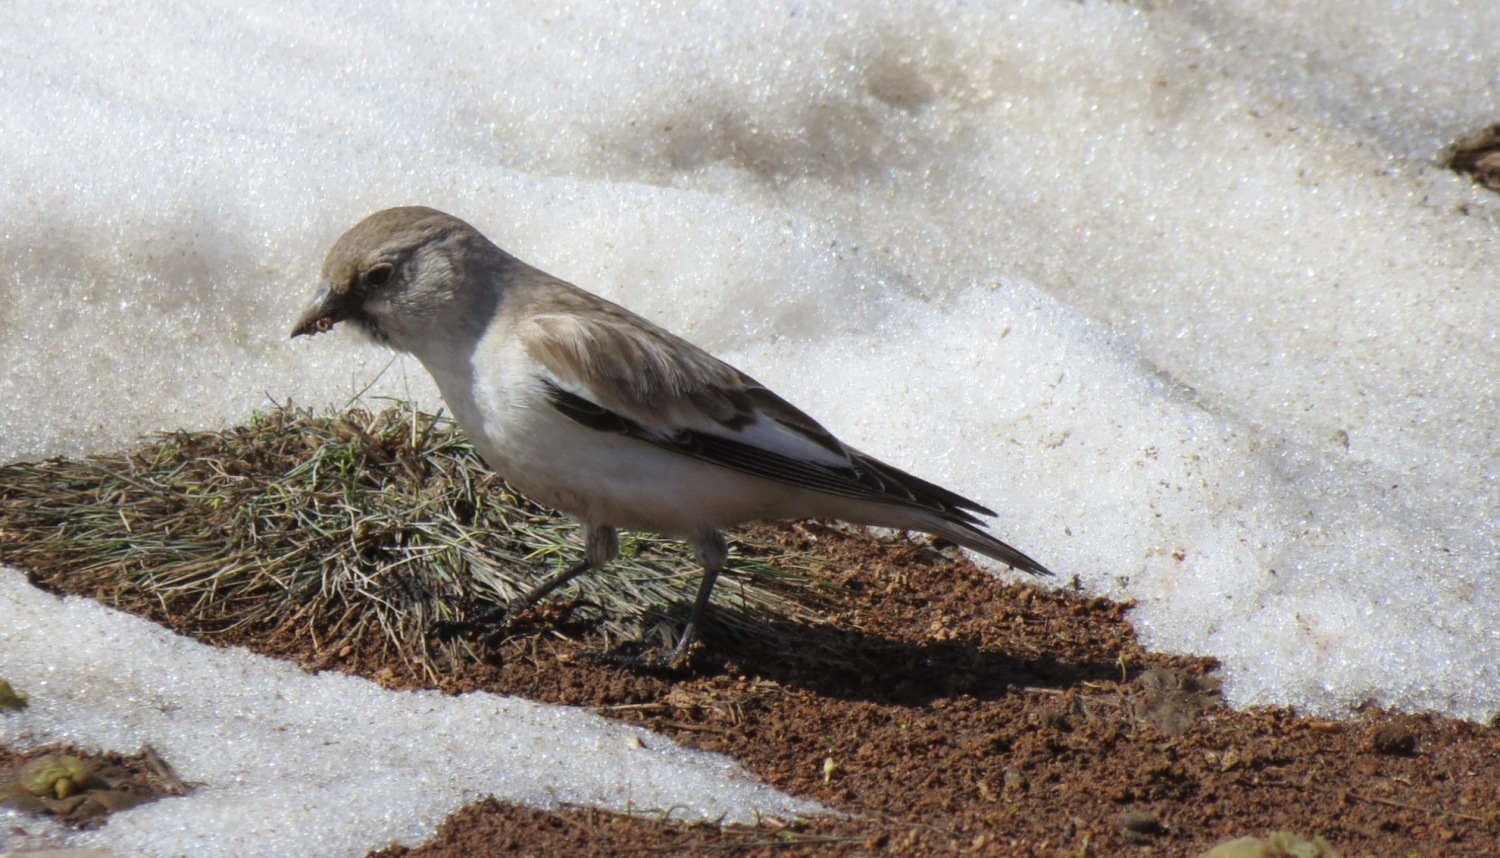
[{"xmin": 518, "ymin": 282, "xmax": 995, "ymax": 525}]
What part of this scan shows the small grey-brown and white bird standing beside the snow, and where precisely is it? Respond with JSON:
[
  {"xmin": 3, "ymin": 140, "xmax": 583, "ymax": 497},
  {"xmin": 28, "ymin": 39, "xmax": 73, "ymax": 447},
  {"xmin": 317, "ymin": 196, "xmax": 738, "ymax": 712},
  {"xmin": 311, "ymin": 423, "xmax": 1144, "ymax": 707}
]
[{"xmin": 291, "ymin": 206, "xmax": 1052, "ymax": 668}]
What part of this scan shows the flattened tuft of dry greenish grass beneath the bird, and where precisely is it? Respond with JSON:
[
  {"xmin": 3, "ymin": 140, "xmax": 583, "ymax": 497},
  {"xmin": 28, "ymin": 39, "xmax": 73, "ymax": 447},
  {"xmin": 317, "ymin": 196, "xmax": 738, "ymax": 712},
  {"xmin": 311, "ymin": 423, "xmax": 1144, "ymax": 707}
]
[{"xmin": 0, "ymin": 404, "xmax": 827, "ymax": 671}]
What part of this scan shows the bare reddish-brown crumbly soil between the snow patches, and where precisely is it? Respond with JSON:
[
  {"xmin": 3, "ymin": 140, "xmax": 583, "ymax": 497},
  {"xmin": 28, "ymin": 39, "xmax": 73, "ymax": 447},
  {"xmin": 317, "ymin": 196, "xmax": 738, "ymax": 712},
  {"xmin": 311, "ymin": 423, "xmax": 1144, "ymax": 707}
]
[{"xmin": 11, "ymin": 525, "xmax": 1500, "ymax": 858}]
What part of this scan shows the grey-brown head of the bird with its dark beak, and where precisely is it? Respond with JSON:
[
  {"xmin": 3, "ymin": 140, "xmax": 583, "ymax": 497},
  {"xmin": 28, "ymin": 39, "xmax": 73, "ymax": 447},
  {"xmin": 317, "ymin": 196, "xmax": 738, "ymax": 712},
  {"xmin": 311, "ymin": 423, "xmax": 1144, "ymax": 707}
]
[{"xmin": 291, "ymin": 206, "xmax": 513, "ymax": 351}]
